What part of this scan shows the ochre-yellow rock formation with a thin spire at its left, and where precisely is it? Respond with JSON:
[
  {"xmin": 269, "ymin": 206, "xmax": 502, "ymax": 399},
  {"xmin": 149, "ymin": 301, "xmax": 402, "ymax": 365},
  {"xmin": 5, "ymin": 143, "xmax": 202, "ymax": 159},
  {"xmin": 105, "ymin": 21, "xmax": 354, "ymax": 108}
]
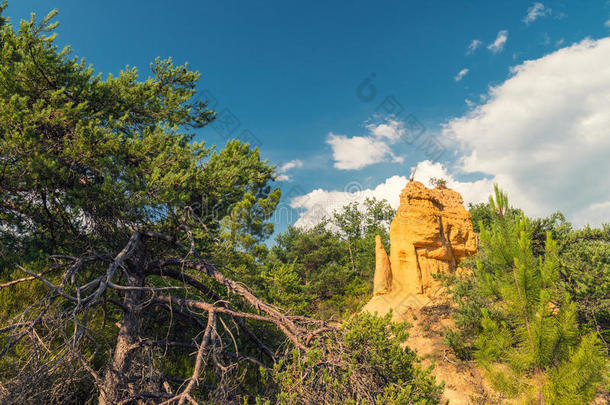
[{"xmin": 364, "ymin": 181, "xmax": 477, "ymax": 318}]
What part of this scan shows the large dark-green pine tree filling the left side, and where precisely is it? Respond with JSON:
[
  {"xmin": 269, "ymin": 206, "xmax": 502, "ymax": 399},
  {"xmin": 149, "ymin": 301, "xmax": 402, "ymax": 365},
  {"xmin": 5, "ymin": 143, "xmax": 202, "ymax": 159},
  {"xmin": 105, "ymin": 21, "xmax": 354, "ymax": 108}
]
[{"xmin": 0, "ymin": 6, "xmax": 280, "ymax": 404}]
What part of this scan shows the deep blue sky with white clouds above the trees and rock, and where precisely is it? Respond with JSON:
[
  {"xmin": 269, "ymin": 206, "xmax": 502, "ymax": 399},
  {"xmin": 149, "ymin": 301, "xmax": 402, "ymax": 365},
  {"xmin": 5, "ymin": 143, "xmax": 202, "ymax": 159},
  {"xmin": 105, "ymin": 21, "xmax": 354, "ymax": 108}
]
[{"xmin": 6, "ymin": 0, "xmax": 610, "ymax": 234}]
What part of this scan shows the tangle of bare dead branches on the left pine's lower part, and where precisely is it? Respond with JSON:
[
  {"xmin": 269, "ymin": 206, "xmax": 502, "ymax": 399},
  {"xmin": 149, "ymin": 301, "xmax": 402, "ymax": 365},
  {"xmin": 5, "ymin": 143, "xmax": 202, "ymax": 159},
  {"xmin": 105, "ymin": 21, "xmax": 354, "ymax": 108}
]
[{"xmin": 0, "ymin": 226, "xmax": 335, "ymax": 405}]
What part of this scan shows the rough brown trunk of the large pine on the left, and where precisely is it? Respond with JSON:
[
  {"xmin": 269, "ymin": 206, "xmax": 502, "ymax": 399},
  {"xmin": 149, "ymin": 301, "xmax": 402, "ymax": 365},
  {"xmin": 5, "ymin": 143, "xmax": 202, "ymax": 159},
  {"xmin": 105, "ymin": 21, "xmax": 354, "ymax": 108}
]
[{"xmin": 99, "ymin": 240, "xmax": 146, "ymax": 405}]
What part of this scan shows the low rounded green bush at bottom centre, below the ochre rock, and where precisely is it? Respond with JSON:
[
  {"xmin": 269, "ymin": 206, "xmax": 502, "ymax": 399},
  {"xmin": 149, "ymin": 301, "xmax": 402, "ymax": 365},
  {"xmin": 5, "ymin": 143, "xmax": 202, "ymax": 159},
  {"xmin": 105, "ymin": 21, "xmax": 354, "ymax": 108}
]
[{"xmin": 259, "ymin": 314, "xmax": 442, "ymax": 405}]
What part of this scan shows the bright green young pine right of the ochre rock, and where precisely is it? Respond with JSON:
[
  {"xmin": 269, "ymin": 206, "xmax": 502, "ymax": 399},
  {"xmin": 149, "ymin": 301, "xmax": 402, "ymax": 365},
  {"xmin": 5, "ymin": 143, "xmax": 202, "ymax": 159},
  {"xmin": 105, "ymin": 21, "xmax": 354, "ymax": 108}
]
[{"xmin": 464, "ymin": 186, "xmax": 606, "ymax": 404}]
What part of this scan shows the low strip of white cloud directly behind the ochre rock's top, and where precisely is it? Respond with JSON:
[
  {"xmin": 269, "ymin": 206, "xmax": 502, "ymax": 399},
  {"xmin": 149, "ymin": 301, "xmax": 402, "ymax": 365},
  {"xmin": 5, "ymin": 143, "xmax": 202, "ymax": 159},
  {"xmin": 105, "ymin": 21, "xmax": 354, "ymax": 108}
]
[{"xmin": 290, "ymin": 160, "xmax": 493, "ymax": 228}]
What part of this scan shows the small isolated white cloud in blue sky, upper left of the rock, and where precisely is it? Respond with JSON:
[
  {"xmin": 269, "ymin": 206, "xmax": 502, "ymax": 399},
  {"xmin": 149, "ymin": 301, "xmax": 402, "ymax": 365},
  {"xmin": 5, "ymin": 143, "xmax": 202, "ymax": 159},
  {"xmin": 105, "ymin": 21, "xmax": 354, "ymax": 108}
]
[{"xmin": 326, "ymin": 120, "xmax": 405, "ymax": 170}]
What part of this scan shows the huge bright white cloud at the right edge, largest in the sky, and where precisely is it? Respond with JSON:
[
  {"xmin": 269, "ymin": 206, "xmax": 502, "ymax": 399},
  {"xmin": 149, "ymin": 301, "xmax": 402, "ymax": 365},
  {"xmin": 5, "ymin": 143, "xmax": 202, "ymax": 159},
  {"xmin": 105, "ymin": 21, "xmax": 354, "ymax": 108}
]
[{"xmin": 443, "ymin": 37, "xmax": 610, "ymax": 225}]
